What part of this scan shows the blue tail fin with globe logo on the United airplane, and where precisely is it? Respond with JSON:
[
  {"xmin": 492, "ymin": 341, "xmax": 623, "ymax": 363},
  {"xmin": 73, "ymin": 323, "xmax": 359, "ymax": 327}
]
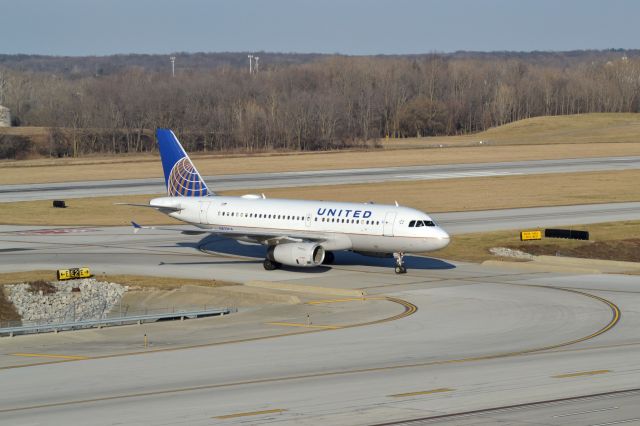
[{"xmin": 156, "ymin": 129, "xmax": 214, "ymax": 197}]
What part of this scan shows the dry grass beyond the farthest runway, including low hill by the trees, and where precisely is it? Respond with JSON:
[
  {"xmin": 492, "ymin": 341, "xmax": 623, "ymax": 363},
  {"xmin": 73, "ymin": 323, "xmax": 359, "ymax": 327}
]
[{"xmin": 0, "ymin": 114, "xmax": 640, "ymax": 187}]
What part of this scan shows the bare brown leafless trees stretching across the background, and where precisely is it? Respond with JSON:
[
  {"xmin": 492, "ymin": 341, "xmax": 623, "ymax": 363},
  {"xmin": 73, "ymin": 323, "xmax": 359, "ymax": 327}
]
[{"xmin": 0, "ymin": 52, "xmax": 640, "ymax": 156}]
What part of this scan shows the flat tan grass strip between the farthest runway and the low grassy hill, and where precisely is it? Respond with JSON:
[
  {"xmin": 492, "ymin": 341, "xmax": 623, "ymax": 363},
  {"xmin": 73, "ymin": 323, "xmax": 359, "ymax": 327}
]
[{"xmin": 5, "ymin": 142, "xmax": 640, "ymax": 188}]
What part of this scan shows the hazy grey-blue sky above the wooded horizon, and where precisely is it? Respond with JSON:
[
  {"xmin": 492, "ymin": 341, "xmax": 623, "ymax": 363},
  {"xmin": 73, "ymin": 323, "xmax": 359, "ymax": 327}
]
[{"xmin": 0, "ymin": 0, "xmax": 640, "ymax": 56}]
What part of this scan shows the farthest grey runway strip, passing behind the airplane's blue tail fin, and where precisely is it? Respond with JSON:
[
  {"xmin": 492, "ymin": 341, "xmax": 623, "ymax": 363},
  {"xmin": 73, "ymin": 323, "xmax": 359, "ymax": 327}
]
[{"xmin": 0, "ymin": 157, "xmax": 640, "ymax": 203}]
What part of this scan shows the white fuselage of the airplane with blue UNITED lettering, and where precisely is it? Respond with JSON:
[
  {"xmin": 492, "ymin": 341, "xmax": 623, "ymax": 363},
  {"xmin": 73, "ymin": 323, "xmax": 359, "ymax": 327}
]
[{"xmin": 150, "ymin": 196, "xmax": 449, "ymax": 254}]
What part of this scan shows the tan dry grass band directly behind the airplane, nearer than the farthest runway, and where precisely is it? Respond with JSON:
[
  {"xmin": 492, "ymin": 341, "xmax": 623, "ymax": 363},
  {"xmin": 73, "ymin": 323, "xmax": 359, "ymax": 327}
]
[{"xmin": 0, "ymin": 170, "xmax": 640, "ymax": 226}]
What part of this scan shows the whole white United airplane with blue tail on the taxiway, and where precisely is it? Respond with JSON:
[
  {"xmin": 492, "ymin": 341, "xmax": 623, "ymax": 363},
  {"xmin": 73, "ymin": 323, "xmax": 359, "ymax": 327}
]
[{"xmin": 122, "ymin": 128, "xmax": 450, "ymax": 274}]
